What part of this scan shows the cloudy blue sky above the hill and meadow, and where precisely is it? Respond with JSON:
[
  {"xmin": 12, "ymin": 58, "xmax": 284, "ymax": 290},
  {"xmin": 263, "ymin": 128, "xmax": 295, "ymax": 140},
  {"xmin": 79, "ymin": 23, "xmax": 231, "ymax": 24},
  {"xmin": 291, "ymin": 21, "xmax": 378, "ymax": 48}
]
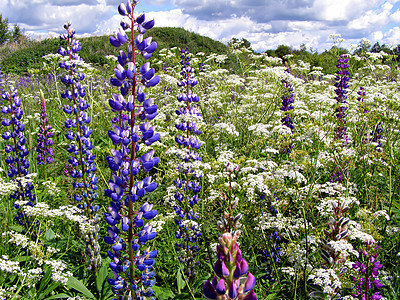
[{"xmin": 0, "ymin": 0, "xmax": 400, "ymax": 52}]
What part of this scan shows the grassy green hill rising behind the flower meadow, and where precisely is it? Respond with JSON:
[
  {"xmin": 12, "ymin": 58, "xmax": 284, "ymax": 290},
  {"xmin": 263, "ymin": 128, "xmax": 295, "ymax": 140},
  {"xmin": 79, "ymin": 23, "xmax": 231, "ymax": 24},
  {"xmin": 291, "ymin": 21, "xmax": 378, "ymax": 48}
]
[{"xmin": 0, "ymin": 27, "xmax": 228, "ymax": 74}]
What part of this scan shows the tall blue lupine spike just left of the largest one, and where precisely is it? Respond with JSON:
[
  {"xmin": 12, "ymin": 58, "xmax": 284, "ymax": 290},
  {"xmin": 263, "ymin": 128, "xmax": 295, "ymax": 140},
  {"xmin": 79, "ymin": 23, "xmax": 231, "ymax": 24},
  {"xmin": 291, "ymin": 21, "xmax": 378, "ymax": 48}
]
[{"xmin": 58, "ymin": 23, "xmax": 101, "ymax": 272}]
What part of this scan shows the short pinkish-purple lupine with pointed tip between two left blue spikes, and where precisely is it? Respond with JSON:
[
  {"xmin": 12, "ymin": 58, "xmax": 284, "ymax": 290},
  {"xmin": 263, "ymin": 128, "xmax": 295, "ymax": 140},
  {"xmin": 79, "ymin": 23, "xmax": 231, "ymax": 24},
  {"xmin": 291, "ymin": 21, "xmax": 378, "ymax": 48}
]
[{"xmin": 36, "ymin": 91, "xmax": 54, "ymax": 165}]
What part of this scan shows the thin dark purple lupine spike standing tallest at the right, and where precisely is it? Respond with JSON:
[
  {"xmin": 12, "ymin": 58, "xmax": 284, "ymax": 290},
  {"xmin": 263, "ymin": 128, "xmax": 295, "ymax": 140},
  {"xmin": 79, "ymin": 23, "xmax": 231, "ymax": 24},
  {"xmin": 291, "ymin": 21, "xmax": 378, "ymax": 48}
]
[{"xmin": 335, "ymin": 54, "xmax": 350, "ymax": 147}]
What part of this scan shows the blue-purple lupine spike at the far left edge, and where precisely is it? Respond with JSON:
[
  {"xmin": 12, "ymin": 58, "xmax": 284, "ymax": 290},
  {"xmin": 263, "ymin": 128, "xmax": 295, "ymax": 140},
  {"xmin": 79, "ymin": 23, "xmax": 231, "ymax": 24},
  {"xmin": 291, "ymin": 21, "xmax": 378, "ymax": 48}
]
[{"xmin": 1, "ymin": 86, "xmax": 36, "ymax": 230}]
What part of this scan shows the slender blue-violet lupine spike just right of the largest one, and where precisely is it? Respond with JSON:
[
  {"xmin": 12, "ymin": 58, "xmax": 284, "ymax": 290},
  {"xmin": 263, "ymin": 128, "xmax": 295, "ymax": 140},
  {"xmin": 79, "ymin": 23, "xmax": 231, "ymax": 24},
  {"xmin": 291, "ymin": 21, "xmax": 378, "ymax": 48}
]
[{"xmin": 174, "ymin": 48, "xmax": 201, "ymax": 281}]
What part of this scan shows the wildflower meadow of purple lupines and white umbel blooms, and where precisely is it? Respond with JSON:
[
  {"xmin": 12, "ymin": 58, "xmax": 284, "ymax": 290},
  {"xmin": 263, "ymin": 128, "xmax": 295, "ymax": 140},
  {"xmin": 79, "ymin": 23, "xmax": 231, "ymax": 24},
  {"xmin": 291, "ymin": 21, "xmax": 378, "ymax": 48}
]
[{"xmin": 0, "ymin": 1, "xmax": 400, "ymax": 300}]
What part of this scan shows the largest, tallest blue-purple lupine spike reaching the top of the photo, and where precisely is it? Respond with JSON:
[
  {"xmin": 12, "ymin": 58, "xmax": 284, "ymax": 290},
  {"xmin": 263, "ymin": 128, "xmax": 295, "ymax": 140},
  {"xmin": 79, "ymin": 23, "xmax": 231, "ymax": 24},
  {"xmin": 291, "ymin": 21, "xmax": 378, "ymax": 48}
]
[{"xmin": 104, "ymin": 1, "xmax": 160, "ymax": 299}]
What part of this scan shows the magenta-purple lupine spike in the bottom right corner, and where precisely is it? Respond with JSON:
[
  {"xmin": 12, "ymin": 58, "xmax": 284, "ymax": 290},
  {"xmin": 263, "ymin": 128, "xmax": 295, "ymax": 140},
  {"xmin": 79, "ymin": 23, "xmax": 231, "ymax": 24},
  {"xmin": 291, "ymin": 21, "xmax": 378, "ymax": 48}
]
[{"xmin": 351, "ymin": 241, "xmax": 383, "ymax": 300}]
